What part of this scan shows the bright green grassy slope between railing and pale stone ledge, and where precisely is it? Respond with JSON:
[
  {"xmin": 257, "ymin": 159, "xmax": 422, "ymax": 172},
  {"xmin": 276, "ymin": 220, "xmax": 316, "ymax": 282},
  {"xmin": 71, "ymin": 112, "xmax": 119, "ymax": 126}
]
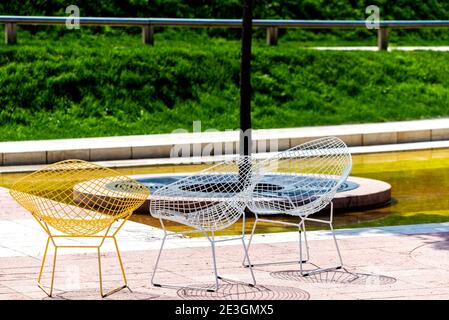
[{"xmin": 0, "ymin": 33, "xmax": 449, "ymax": 141}]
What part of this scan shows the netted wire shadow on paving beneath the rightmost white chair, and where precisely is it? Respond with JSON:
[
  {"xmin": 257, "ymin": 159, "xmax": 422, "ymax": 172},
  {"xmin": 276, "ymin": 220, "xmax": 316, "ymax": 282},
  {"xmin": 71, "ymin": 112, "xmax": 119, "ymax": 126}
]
[{"xmin": 270, "ymin": 269, "xmax": 396, "ymax": 286}]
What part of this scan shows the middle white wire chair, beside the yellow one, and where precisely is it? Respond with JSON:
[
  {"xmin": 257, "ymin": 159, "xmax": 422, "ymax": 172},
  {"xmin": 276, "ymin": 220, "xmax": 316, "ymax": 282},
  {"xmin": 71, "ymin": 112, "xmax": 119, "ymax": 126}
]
[{"xmin": 150, "ymin": 157, "xmax": 261, "ymax": 292}]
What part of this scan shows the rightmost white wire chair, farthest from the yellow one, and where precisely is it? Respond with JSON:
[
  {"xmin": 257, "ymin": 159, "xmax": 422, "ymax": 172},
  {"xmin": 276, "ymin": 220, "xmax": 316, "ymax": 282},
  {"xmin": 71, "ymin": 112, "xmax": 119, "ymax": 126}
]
[{"xmin": 243, "ymin": 137, "xmax": 352, "ymax": 276}]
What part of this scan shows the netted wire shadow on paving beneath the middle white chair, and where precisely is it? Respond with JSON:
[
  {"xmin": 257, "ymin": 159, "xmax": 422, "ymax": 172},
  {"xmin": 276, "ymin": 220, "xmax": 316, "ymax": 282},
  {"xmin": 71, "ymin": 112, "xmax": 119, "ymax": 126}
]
[{"xmin": 177, "ymin": 280, "xmax": 310, "ymax": 300}]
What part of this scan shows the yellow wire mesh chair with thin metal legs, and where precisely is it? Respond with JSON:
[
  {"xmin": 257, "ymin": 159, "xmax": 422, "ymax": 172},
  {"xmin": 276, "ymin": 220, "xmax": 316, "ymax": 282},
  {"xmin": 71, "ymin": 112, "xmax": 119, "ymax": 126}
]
[{"xmin": 10, "ymin": 160, "xmax": 150, "ymax": 297}]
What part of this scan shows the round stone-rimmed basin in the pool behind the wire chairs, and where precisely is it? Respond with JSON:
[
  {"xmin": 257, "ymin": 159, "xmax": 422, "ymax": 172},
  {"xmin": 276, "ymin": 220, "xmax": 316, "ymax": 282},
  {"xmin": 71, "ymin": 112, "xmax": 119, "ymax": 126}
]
[{"xmin": 74, "ymin": 174, "xmax": 391, "ymax": 213}]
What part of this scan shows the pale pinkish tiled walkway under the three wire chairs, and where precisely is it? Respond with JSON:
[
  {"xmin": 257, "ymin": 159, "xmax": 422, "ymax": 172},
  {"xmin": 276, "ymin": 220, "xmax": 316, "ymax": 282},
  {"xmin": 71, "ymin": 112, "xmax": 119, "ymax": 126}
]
[{"xmin": 0, "ymin": 189, "xmax": 449, "ymax": 300}]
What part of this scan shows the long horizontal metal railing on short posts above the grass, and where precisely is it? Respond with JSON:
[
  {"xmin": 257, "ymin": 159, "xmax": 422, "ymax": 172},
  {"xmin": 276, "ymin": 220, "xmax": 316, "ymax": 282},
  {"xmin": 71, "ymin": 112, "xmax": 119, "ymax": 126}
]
[{"xmin": 0, "ymin": 16, "xmax": 449, "ymax": 50}]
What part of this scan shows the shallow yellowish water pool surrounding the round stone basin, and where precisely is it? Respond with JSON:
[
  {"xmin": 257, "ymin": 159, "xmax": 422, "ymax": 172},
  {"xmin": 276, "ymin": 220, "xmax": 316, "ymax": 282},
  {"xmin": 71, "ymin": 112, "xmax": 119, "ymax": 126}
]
[{"xmin": 0, "ymin": 149, "xmax": 449, "ymax": 234}]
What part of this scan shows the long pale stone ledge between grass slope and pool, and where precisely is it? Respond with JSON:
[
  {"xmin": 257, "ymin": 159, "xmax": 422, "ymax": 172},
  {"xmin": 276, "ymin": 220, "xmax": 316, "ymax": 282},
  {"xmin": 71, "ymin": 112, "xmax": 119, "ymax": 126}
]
[{"xmin": 0, "ymin": 118, "xmax": 449, "ymax": 166}]
